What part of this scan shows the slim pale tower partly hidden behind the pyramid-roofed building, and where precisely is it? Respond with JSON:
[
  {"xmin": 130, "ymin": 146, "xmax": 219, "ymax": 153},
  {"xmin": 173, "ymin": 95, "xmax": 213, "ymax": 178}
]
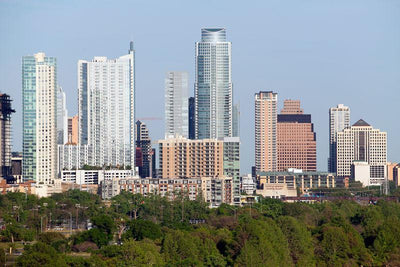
[{"xmin": 328, "ymin": 104, "xmax": 350, "ymax": 172}]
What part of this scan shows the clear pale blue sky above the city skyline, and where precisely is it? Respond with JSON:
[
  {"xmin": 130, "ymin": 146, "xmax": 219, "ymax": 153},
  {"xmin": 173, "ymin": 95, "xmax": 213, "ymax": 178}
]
[{"xmin": 0, "ymin": 0, "xmax": 400, "ymax": 173}]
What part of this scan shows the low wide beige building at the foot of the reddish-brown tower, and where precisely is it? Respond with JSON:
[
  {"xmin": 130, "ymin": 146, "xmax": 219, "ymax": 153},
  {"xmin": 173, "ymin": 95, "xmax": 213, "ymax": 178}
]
[{"xmin": 256, "ymin": 169, "xmax": 336, "ymax": 198}]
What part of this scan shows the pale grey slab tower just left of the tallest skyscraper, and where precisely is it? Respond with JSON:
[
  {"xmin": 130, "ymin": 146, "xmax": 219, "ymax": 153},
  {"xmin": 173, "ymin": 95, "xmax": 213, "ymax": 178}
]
[{"xmin": 165, "ymin": 71, "xmax": 189, "ymax": 138}]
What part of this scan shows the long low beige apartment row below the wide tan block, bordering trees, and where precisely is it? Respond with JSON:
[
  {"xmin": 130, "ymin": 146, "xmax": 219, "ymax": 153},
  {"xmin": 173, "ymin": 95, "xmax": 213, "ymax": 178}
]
[{"xmin": 101, "ymin": 177, "xmax": 233, "ymax": 208}]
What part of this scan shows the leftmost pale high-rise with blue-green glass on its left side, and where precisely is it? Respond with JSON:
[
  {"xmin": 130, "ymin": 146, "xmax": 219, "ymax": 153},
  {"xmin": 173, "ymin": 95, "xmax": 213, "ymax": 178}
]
[{"xmin": 22, "ymin": 53, "xmax": 57, "ymax": 185}]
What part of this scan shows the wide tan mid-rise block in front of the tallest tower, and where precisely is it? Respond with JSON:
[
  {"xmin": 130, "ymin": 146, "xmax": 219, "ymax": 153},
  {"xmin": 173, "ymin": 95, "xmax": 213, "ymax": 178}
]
[{"xmin": 159, "ymin": 137, "xmax": 224, "ymax": 178}]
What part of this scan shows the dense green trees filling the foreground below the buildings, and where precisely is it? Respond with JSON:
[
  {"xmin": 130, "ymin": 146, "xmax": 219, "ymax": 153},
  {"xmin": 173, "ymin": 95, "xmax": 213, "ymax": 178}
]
[{"xmin": 0, "ymin": 190, "xmax": 400, "ymax": 267}]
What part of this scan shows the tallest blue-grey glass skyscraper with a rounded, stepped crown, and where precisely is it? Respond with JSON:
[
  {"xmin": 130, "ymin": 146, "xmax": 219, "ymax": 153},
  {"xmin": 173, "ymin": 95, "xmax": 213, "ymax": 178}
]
[{"xmin": 195, "ymin": 28, "xmax": 233, "ymax": 139}]
